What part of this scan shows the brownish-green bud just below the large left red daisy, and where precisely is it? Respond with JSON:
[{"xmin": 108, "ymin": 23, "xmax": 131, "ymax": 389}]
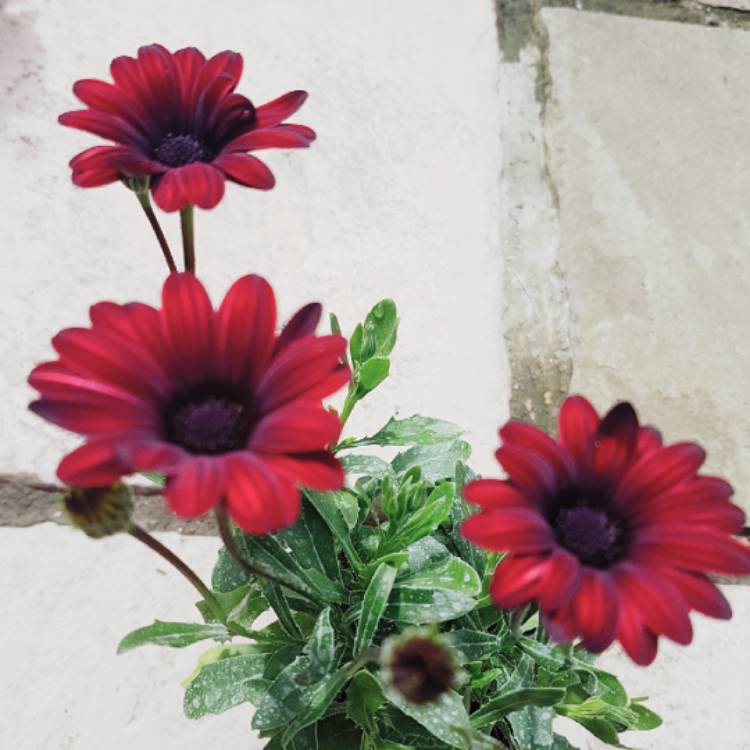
[{"xmin": 59, "ymin": 483, "xmax": 133, "ymax": 539}]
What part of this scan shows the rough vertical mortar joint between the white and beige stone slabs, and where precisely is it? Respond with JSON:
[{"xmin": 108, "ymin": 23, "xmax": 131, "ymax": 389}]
[{"xmin": 495, "ymin": 0, "xmax": 573, "ymax": 432}]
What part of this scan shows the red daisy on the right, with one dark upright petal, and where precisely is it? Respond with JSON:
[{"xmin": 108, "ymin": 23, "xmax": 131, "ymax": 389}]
[{"xmin": 462, "ymin": 396, "xmax": 750, "ymax": 664}]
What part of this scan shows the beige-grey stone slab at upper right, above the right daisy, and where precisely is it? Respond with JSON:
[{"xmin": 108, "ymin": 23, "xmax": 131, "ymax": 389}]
[{"xmin": 542, "ymin": 9, "xmax": 750, "ymax": 508}]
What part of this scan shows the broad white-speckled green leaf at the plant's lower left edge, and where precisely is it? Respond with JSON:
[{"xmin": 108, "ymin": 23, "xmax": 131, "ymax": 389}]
[{"xmin": 183, "ymin": 654, "xmax": 269, "ymax": 719}]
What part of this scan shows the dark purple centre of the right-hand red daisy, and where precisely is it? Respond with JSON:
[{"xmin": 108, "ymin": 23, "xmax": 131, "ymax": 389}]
[{"xmin": 553, "ymin": 506, "xmax": 624, "ymax": 568}]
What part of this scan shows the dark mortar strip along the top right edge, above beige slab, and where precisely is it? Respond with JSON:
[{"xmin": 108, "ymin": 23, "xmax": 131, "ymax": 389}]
[{"xmin": 540, "ymin": 0, "xmax": 750, "ymax": 29}]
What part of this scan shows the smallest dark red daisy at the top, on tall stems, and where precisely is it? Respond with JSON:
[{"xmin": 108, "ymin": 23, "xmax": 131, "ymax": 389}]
[{"xmin": 60, "ymin": 44, "xmax": 315, "ymax": 211}]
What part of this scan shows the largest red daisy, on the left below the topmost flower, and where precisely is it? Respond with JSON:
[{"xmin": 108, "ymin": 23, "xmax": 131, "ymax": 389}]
[{"xmin": 29, "ymin": 274, "xmax": 349, "ymax": 534}]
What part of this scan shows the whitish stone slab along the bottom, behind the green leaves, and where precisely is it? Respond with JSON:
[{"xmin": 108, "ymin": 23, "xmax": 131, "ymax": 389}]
[{"xmin": 5, "ymin": 524, "xmax": 750, "ymax": 750}]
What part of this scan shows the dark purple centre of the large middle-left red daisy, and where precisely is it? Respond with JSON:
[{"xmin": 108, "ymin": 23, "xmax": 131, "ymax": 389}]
[{"xmin": 167, "ymin": 396, "xmax": 251, "ymax": 454}]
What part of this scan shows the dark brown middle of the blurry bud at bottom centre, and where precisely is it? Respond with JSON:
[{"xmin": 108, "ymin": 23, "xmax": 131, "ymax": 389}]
[{"xmin": 390, "ymin": 637, "xmax": 454, "ymax": 704}]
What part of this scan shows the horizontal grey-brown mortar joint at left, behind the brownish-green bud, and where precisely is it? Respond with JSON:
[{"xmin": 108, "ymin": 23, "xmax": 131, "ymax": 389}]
[{"xmin": 0, "ymin": 474, "xmax": 217, "ymax": 536}]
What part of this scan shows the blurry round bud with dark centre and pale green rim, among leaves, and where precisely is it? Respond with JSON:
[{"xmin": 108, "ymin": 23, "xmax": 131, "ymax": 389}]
[{"xmin": 381, "ymin": 628, "xmax": 457, "ymax": 705}]
